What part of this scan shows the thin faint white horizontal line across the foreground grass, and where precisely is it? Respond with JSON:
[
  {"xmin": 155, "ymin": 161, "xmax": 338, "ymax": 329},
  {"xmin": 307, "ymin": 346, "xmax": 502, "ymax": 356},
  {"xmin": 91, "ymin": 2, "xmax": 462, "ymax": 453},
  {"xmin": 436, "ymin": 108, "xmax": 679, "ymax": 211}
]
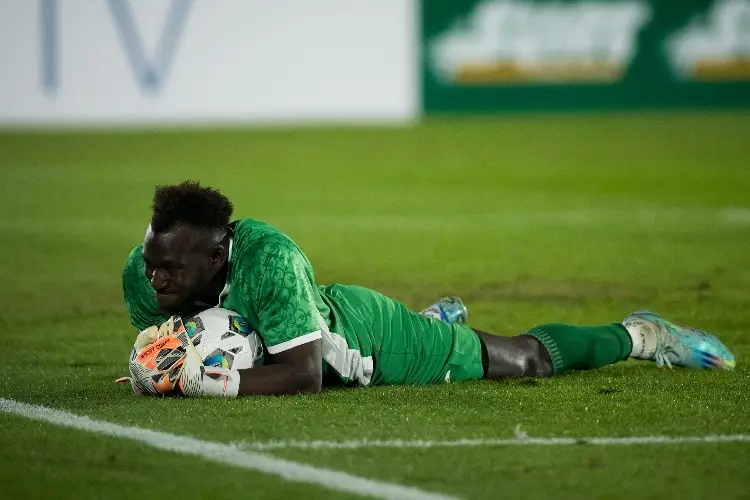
[{"xmin": 245, "ymin": 434, "xmax": 750, "ymax": 451}]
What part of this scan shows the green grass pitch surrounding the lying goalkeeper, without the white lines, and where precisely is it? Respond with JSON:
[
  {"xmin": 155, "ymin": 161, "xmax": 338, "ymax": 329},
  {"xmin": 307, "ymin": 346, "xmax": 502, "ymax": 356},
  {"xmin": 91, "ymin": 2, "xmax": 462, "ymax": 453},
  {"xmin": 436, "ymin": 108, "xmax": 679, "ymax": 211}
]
[{"xmin": 0, "ymin": 112, "xmax": 750, "ymax": 499}]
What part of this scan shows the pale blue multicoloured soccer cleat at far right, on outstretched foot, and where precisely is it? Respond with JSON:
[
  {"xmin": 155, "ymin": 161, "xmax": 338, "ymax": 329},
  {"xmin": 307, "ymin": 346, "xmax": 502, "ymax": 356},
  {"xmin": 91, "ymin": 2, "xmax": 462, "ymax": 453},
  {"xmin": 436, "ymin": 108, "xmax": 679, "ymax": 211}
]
[{"xmin": 622, "ymin": 311, "xmax": 735, "ymax": 370}]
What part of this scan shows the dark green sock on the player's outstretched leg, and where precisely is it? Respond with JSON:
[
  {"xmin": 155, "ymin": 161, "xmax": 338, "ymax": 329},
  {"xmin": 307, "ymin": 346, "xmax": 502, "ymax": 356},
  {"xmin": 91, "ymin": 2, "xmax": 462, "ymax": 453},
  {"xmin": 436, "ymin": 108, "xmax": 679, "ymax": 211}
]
[{"xmin": 526, "ymin": 323, "xmax": 633, "ymax": 373}]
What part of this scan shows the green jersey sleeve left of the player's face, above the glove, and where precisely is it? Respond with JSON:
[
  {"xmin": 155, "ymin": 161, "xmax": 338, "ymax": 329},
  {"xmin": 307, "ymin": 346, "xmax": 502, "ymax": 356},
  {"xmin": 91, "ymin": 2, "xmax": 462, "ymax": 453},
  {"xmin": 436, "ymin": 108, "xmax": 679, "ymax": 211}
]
[{"xmin": 122, "ymin": 245, "xmax": 169, "ymax": 330}]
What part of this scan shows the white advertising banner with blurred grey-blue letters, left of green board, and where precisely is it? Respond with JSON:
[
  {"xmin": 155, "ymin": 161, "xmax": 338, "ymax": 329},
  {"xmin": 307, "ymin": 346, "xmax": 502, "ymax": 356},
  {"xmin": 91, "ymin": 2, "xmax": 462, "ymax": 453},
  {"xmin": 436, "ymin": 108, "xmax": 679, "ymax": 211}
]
[{"xmin": 0, "ymin": 0, "xmax": 419, "ymax": 126}]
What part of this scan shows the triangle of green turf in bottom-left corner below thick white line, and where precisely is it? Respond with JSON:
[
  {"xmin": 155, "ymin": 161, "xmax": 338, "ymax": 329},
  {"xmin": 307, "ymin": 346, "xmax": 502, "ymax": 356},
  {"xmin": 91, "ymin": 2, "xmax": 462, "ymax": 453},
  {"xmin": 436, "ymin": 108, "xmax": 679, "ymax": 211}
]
[{"xmin": 0, "ymin": 413, "xmax": 356, "ymax": 500}]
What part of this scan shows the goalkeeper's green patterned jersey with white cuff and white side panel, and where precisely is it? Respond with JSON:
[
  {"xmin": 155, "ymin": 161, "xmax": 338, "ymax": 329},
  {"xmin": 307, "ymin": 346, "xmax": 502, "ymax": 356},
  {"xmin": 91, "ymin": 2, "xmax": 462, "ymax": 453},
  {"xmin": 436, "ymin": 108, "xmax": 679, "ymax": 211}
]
[{"xmin": 123, "ymin": 219, "xmax": 375, "ymax": 385}]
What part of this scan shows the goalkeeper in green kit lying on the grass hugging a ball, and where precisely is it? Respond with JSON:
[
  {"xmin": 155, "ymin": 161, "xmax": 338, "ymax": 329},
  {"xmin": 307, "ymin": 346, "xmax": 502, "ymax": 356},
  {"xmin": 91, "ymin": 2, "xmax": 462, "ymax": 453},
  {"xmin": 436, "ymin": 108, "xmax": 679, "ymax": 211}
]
[{"xmin": 123, "ymin": 181, "xmax": 734, "ymax": 397}]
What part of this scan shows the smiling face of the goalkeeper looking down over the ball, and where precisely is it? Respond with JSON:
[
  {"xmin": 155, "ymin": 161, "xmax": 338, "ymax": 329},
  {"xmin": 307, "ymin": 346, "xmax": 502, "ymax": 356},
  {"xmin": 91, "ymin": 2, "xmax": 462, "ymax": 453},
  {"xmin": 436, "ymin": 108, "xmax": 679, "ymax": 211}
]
[{"xmin": 143, "ymin": 225, "xmax": 214, "ymax": 314}]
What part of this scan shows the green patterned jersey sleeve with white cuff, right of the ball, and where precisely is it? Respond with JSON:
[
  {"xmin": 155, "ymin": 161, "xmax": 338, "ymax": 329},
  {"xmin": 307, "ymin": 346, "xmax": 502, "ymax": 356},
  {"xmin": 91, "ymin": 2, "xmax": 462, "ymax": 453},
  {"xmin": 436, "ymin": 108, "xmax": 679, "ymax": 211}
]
[{"xmin": 255, "ymin": 237, "xmax": 321, "ymax": 354}]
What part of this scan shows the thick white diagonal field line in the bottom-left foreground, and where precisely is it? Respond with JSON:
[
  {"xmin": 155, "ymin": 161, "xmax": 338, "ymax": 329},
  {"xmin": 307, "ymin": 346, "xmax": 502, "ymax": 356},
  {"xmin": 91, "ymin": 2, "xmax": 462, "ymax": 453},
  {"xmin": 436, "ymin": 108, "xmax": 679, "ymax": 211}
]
[{"xmin": 0, "ymin": 398, "xmax": 454, "ymax": 500}]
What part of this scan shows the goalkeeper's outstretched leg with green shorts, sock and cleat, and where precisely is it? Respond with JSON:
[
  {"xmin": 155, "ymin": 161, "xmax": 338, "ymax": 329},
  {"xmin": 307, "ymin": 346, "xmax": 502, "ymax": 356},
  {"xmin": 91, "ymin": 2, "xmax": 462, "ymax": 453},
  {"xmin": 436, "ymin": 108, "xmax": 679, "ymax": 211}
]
[{"xmin": 326, "ymin": 286, "xmax": 734, "ymax": 385}]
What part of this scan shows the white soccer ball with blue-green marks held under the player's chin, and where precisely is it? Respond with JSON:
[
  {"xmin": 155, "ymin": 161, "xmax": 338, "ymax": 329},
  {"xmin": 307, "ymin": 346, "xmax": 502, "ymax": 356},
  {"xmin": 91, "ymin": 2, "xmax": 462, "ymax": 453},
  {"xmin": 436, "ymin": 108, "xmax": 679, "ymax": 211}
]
[{"xmin": 182, "ymin": 307, "xmax": 263, "ymax": 370}]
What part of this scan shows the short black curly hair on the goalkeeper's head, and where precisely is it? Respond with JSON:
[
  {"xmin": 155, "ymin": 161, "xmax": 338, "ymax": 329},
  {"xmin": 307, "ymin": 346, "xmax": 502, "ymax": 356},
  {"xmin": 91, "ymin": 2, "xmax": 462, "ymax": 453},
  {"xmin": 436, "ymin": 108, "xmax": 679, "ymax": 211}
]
[{"xmin": 151, "ymin": 180, "xmax": 234, "ymax": 232}]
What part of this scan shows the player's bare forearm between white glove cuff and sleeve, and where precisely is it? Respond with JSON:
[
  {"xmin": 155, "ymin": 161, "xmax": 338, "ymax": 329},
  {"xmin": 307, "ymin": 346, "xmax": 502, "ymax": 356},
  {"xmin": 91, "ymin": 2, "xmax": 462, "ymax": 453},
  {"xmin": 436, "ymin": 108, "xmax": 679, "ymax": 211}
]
[{"xmin": 238, "ymin": 363, "xmax": 323, "ymax": 396}]
